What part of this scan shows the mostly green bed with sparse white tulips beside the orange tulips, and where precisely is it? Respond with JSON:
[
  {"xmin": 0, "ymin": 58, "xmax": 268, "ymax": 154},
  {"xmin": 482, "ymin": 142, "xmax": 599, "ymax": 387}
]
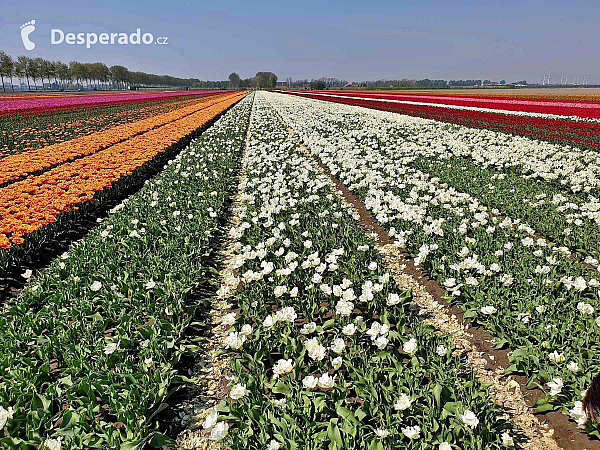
[{"xmin": 0, "ymin": 93, "xmax": 251, "ymax": 450}]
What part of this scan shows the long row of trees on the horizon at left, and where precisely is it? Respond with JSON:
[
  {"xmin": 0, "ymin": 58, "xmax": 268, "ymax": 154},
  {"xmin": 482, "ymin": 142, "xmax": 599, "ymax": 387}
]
[{"xmin": 0, "ymin": 50, "xmax": 216, "ymax": 90}]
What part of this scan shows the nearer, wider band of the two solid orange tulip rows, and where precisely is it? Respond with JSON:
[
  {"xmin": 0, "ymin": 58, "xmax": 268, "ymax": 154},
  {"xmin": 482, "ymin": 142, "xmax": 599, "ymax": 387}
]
[{"xmin": 0, "ymin": 93, "xmax": 241, "ymax": 249}]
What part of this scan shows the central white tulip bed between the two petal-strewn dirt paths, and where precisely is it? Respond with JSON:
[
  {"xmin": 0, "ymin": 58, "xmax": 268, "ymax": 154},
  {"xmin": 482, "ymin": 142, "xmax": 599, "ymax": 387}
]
[{"xmin": 209, "ymin": 93, "xmax": 515, "ymax": 450}]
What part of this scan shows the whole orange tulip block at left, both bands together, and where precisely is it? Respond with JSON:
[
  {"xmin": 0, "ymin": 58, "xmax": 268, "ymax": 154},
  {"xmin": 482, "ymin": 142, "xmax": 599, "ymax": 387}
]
[{"xmin": 0, "ymin": 93, "xmax": 244, "ymax": 270}]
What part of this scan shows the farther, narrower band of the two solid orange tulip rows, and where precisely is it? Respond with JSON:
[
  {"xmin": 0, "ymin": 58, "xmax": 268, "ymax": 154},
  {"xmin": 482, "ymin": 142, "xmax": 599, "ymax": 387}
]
[{"xmin": 0, "ymin": 94, "xmax": 235, "ymax": 185}]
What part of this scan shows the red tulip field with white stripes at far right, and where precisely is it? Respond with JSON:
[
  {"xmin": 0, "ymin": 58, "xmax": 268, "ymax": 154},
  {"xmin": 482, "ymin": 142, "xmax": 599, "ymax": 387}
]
[{"xmin": 288, "ymin": 91, "xmax": 600, "ymax": 150}]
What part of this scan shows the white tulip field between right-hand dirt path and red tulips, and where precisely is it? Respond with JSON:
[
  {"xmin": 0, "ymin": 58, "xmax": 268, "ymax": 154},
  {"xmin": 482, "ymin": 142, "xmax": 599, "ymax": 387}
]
[{"xmin": 273, "ymin": 89, "xmax": 600, "ymax": 442}]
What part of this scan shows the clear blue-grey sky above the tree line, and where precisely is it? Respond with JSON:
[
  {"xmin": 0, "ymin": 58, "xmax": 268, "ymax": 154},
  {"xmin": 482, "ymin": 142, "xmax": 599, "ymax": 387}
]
[{"xmin": 0, "ymin": 0, "xmax": 600, "ymax": 83}]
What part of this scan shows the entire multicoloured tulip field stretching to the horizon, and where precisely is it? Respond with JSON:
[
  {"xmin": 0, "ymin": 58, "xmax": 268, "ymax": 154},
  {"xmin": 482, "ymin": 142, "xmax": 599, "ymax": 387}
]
[{"xmin": 0, "ymin": 91, "xmax": 600, "ymax": 450}]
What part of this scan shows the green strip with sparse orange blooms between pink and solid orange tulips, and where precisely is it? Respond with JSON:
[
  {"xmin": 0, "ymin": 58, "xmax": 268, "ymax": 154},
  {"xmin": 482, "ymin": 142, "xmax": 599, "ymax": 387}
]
[{"xmin": 0, "ymin": 95, "xmax": 213, "ymax": 158}]
